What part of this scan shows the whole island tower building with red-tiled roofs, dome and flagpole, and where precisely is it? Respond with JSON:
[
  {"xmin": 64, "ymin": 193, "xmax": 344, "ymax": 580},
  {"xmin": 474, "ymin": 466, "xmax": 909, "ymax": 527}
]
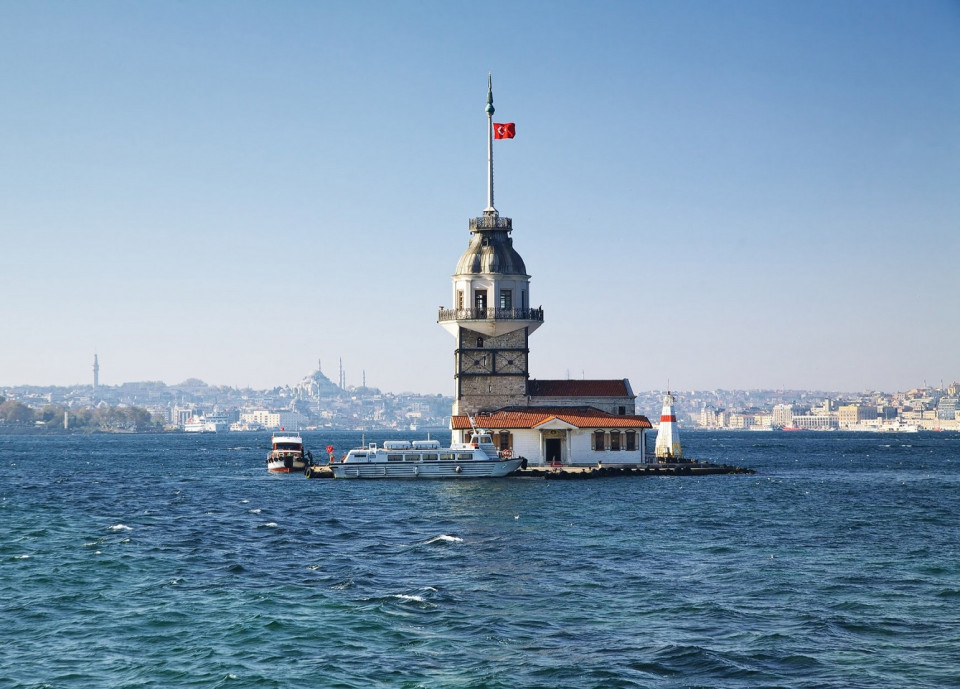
[{"xmin": 437, "ymin": 80, "xmax": 652, "ymax": 466}]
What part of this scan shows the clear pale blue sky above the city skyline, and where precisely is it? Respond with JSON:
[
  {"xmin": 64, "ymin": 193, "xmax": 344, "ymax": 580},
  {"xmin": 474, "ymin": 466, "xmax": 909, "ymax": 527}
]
[{"xmin": 0, "ymin": 0, "xmax": 960, "ymax": 395}]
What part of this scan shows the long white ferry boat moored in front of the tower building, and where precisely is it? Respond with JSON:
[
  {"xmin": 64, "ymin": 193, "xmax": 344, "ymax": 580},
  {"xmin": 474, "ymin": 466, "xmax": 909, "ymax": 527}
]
[{"xmin": 330, "ymin": 431, "xmax": 524, "ymax": 478}]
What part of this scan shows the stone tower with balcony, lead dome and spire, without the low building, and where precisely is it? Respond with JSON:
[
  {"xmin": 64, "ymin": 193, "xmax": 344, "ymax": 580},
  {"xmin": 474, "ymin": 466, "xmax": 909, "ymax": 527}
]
[{"xmin": 437, "ymin": 76, "xmax": 543, "ymax": 415}]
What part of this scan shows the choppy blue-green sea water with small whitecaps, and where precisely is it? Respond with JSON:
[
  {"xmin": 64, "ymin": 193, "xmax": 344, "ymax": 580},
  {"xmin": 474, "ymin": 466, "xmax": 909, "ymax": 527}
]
[{"xmin": 0, "ymin": 431, "xmax": 960, "ymax": 689}]
